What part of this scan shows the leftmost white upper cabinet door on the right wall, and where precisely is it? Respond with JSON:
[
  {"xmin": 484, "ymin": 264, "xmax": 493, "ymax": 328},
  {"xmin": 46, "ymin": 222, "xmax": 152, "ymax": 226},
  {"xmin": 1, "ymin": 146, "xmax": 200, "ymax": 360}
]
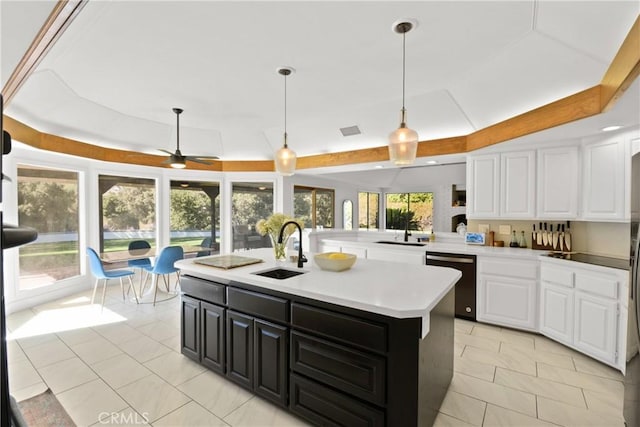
[{"xmin": 467, "ymin": 154, "xmax": 500, "ymax": 218}]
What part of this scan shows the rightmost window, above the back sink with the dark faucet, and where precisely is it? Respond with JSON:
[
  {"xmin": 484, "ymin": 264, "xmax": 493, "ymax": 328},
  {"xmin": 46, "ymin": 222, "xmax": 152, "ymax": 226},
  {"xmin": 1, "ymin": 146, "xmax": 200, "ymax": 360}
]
[{"xmin": 385, "ymin": 193, "xmax": 433, "ymax": 233}]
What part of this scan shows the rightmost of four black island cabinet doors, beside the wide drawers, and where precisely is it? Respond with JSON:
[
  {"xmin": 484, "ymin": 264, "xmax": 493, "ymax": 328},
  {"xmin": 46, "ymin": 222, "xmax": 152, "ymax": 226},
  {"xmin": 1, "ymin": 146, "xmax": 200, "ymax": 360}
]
[{"xmin": 254, "ymin": 319, "xmax": 289, "ymax": 406}]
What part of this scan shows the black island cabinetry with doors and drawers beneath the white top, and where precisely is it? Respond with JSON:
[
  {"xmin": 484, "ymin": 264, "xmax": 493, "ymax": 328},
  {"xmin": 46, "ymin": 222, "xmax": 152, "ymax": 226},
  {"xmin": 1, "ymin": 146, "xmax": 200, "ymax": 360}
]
[{"xmin": 181, "ymin": 275, "xmax": 454, "ymax": 427}]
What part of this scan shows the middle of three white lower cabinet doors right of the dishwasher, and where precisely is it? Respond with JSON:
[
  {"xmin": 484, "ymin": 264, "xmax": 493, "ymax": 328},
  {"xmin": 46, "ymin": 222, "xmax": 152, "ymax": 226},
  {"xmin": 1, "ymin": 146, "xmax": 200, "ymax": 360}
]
[{"xmin": 540, "ymin": 282, "xmax": 573, "ymax": 345}]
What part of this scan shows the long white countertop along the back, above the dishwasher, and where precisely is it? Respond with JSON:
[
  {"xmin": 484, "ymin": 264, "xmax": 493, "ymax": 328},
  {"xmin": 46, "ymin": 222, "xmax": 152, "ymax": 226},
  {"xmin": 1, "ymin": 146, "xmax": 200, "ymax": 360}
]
[{"xmin": 322, "ymin": 236, "xmax": 549, "ymax": 260}]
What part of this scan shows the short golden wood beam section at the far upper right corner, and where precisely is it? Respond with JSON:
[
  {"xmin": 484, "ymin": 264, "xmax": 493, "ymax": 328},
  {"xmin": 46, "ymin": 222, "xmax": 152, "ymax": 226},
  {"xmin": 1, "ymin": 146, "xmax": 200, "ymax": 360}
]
[{"xmin": 600, "ymin": 16, "xmax": 640, "ymax": 112}]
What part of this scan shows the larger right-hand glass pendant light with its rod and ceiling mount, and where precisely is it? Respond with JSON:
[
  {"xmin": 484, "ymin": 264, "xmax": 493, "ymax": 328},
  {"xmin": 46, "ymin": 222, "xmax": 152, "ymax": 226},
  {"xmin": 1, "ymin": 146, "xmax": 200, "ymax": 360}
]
[{"xmin": 389, "ymin": 21, "xmax": 418, "ymax": 165}]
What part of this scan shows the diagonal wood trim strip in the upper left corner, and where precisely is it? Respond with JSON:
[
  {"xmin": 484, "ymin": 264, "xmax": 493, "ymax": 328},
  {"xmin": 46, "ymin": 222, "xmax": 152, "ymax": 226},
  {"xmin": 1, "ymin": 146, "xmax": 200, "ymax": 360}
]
[{"xmin": 2, "ymin": 0, "xmax": 88, "ymax": 108}]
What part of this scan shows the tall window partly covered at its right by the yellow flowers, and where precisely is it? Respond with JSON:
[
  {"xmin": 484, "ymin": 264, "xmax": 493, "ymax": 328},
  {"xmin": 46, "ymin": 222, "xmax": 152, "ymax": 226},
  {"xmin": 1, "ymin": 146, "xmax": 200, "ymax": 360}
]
[{"xmin": 231, "ymin": 182, "xmax": 273, "ymax": 251}]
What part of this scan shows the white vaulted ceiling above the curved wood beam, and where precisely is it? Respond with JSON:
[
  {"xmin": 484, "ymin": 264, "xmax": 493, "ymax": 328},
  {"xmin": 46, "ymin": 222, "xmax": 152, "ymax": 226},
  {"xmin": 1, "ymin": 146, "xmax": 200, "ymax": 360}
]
[{"xmin": 0, "ymin": 0, "xmax": 640, "ymax": 172}]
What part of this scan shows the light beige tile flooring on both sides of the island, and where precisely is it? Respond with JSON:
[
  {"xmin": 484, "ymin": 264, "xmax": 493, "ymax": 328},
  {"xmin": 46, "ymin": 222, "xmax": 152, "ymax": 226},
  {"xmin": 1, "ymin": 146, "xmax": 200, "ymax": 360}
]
[{"xmin": 7, "ymin": 286, "xmax": 624, "ymax": 427}]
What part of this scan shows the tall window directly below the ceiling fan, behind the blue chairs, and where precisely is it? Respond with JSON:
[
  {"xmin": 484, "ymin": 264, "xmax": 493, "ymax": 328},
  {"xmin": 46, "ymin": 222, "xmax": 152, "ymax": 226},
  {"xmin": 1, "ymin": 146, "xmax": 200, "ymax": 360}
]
[{"xmin": 169, "ymin": 181, "xmax": 220, "ymax": 253}]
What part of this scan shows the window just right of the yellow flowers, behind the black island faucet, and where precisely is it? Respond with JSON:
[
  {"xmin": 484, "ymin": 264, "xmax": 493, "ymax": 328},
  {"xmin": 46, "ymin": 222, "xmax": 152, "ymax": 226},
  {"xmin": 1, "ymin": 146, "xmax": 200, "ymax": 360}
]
[{"xmin": 293, "ymin": 185, "xmax": 335, "ymax": 228}]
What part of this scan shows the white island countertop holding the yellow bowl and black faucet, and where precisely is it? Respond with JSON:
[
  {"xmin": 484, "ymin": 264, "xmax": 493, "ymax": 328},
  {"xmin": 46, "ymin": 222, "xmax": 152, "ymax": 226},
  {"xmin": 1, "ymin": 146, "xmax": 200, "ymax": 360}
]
[{"xmin": 175, "ymin": 248, "xmax": 461, "ymax": 336}]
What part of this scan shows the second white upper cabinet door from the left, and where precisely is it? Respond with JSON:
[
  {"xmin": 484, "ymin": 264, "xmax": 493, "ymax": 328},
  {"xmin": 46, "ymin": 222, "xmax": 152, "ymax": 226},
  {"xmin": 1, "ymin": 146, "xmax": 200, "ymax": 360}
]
[{"xmin": 500, "ymin": 151, "xmax": 536, "ymax": 218}]
